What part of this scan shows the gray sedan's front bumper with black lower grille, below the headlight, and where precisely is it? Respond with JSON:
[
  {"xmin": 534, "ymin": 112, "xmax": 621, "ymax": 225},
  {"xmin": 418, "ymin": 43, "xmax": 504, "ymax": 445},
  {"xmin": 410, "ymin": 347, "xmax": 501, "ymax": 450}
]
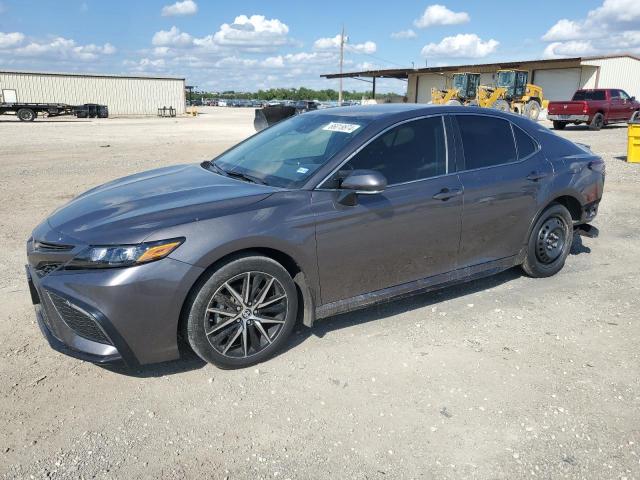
[{"xmin": 27, "ymin": 258, "xmax": 202, "ymax": 367}]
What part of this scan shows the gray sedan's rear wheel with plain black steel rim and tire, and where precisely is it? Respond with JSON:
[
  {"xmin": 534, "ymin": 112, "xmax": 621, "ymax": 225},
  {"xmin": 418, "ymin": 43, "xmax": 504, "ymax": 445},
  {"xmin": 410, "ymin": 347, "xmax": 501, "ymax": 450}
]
[{"xmin": 522, "ymin": 203, "xmax": 573, "ymax": 278}]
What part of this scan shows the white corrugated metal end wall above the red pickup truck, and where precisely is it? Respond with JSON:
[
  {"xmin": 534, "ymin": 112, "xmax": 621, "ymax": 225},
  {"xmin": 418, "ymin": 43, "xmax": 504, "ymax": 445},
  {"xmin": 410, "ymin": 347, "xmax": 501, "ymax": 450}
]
[{"xmin": 582, "ymin": 57, "xmax": 640, "ymax": 98}]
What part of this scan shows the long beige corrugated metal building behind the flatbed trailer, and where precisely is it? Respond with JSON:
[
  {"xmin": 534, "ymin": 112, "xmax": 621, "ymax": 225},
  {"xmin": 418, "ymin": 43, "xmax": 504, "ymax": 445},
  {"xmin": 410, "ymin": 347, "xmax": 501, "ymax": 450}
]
[{"xmin": 0, "ymin": 71, "xmax": 185, "ymax": 115}]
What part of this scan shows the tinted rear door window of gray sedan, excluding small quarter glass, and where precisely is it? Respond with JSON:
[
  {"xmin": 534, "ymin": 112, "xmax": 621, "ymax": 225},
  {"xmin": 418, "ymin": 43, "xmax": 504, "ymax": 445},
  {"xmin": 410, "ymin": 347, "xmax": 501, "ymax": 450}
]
[{"xmin": 456, "ymin": 115, "xmax": 517, "ymax": 170}]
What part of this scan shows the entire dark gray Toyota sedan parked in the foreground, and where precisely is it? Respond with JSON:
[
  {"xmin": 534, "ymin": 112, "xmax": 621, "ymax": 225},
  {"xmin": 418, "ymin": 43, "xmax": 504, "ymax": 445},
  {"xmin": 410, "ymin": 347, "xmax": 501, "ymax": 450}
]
[{"xmin": 27, "ymin": 104, "xmax": 605, "ymax": 368}]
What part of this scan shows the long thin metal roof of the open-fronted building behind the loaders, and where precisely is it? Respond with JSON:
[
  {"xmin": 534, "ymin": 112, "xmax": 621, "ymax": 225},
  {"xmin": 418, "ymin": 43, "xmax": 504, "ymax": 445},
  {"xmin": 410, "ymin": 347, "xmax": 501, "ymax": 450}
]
[{"xmin": 320, "ymin": 54, "xmax": 640, "ymax": 79}]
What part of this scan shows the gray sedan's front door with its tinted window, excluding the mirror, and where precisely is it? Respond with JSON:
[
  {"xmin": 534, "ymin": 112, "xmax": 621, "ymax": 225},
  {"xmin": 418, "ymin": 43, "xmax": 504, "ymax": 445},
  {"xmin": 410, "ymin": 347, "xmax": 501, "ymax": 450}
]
[{"xmin": 312, "ymin": 116, "xmax": 462, "ymax": 304}]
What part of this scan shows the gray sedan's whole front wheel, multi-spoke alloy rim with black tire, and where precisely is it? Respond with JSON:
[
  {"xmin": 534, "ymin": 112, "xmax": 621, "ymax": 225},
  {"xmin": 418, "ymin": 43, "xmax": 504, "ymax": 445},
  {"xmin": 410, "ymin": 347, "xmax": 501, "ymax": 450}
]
[{"xmin": 186, "ymin": 256, "xmax": 298, "ymax": 368}]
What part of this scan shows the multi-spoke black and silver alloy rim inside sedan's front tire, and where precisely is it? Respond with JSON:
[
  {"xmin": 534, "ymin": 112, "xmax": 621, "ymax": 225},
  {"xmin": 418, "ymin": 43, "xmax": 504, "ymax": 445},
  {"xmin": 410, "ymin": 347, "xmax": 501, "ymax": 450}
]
[{"xmin": 204, "ymin": 271, "xmax": 289, "ymax": 358}]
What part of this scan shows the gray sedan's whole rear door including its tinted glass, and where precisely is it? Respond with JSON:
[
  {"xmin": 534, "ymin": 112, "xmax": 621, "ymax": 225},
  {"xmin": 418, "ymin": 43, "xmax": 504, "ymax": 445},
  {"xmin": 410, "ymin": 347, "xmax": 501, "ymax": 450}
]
[{"xmin": 455, "ymin": 114, "xmax": 552, "ymax": 267}]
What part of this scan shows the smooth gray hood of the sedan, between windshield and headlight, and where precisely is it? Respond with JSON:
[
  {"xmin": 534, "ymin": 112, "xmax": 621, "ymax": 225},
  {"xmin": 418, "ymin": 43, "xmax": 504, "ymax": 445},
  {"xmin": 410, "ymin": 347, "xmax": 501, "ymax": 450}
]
[{"xmin": 42, "ymin": 165, "xmax": 278, "ymax": 244}]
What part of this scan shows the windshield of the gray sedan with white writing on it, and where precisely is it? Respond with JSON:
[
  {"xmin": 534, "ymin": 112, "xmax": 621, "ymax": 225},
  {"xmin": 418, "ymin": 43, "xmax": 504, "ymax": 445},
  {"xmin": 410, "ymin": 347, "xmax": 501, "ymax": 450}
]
[{"xmin": 214, "ymin": 114, "xmax": 371, "ymax": 188}]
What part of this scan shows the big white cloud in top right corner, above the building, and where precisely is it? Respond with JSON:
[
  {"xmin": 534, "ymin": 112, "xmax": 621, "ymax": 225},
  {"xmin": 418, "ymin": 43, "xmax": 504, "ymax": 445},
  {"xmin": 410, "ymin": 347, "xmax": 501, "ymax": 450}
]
[{"xmin": 542, "ymin": 0, "xmax": 640, "ymax": 57}]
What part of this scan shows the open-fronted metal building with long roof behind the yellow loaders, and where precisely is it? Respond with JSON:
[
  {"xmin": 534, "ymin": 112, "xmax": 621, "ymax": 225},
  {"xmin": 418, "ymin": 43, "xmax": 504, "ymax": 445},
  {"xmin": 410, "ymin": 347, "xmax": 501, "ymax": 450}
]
[{"xmin": 322, "ymin": 55, "xmax": 640, "ymax": 103}]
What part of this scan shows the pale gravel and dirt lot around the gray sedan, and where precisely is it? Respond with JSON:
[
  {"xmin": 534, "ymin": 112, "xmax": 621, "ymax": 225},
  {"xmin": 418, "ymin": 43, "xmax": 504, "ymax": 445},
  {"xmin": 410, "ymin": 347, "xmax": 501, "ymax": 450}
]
[{"xmin": 0, "ymin": 109, "xmax": 640, "ymax": 480}]
